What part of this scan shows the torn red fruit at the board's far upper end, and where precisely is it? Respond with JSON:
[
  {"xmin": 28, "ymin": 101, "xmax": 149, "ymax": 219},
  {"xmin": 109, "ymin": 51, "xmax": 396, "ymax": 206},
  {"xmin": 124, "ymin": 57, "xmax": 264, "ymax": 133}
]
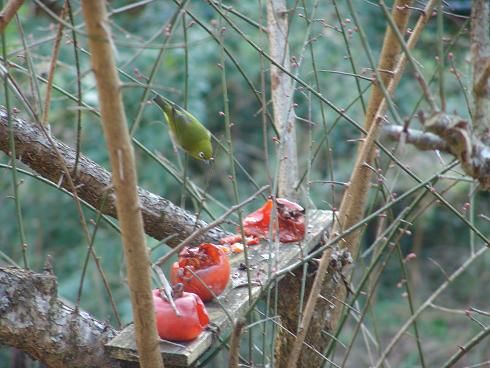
[{"xmin": 243, "ymin": 198, "xmax": 305, "ymax": 243}]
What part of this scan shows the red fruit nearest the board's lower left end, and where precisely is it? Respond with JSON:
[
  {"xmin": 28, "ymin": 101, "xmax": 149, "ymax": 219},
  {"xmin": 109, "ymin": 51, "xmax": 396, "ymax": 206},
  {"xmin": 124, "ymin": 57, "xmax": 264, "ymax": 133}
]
[{"xmin": 153, "ymin": 289, "xmax": 209, "ymax": 341}]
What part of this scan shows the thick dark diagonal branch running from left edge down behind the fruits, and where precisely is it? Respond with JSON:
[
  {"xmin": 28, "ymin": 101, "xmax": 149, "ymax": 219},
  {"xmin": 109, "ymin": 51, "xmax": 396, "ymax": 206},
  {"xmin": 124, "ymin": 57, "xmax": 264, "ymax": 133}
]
[{"xmin": 0, "ymin": 106, "xmax": 227, "ymax": 246}]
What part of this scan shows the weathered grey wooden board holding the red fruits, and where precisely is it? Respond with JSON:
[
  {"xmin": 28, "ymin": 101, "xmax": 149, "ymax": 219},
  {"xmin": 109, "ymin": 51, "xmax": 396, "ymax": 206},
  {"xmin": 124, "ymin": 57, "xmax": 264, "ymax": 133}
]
[{"xmin": 106, "ymin": 210, "xmax": 332, "ymax": 367}]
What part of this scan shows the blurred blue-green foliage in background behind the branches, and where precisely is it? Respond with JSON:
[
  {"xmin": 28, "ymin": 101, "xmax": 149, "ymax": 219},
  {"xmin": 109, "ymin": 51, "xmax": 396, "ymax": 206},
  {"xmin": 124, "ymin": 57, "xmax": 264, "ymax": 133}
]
[{"xmin": 0, "ymin": 0, "xmax": 490, "ymax": 367}]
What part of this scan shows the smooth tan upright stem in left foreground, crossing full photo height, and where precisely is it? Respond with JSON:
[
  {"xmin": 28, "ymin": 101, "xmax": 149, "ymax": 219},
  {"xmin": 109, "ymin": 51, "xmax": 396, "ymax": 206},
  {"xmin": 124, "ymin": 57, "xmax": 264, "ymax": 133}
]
[{"xmin": 82, "ymin": 0, "xmax": 163, "ymax": 368}]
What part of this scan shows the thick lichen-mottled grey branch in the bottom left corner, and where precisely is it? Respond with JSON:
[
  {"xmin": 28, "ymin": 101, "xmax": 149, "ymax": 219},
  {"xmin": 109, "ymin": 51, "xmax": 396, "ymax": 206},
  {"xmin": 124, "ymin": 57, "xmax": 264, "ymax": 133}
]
[{"xmin": 0, "ymin": 268, "xmax": 119, "ymax": 368}]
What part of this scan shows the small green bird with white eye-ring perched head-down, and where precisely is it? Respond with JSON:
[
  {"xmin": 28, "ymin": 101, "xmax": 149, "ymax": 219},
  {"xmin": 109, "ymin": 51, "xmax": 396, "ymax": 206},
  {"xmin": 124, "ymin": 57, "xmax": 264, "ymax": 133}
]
[{"xmin": 153, "ymin": 95, "xmax": 213, "ymax": 161}]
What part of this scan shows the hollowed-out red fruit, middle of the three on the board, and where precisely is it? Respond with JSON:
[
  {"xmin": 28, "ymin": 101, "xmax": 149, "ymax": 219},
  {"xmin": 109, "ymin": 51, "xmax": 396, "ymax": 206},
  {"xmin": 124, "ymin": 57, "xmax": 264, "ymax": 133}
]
[{"xmin": 170, "ymin": 243, "xmax": 231, "ymax": 302}]
